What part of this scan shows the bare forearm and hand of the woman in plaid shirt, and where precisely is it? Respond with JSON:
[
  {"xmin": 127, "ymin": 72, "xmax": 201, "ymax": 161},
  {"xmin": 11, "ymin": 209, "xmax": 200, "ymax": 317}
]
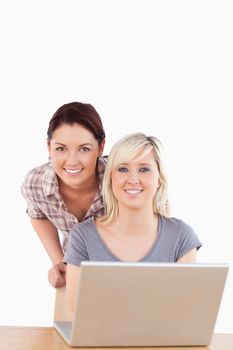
[{"xmin": 31, "ymin": 219, "xmax": 66, "ymax": 288}]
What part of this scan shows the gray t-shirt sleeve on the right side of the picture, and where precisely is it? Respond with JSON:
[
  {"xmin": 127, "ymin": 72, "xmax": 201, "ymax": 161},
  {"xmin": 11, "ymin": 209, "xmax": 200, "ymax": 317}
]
[{"xmin": 176, "ymin": 222, "xmax": 202, "ymax": 260}]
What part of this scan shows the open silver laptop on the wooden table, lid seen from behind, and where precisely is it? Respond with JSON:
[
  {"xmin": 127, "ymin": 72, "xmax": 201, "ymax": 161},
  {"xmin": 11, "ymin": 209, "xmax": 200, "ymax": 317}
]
[{"xmin": 54, "ymin": 262, "xmax": 229, "ymax": 347}]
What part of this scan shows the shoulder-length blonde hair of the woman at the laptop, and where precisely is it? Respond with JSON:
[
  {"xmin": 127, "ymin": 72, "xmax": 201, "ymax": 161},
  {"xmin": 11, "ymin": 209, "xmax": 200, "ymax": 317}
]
[{"xmin": 99, "ymin": 133, "xmax": 168, "ymax": 223}]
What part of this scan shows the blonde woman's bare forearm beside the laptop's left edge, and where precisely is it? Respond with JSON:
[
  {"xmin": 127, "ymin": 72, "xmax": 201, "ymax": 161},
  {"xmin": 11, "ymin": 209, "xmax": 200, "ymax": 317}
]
[{"xmin": 66, "ymin": 264, "xmax": 80, "ymax": 320}]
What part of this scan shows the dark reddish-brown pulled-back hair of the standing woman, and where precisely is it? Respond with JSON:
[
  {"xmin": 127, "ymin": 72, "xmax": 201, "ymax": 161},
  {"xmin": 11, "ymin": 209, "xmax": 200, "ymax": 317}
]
[{"xmin": 47, "ymin": 102, "xmax": 105, "ymax": 145}]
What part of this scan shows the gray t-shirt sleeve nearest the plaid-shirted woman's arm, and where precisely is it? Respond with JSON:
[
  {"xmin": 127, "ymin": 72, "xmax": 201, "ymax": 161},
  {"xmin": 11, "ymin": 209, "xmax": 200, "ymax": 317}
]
[{"xmin": 63, "ymin": 224, "xmax": 89, "ymax": 266}]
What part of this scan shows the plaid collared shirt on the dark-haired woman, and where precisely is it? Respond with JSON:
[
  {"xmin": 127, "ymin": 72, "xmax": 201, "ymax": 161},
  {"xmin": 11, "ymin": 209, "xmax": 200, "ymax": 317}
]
[{"xmin": 21, "ymin": 157, "xmax": 107, "ymax": 251}]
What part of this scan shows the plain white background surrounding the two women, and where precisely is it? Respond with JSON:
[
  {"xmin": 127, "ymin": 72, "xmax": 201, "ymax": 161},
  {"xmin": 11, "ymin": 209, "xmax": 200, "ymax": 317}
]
[{"xmin": 0, "ymin": 0, "xmax": 233, "ymax": 333}]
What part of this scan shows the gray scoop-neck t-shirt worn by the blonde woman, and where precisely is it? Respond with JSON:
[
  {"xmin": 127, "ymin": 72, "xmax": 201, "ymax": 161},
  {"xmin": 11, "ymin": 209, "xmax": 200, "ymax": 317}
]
[{"xmin": 63, "ymin": 216, "xmax": 202, "ymax": 266}]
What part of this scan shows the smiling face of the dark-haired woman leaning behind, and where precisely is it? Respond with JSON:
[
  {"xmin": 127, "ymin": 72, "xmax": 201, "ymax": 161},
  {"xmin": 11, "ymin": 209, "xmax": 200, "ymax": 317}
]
[{"xmin": 48, "ymin": 123, "xmax": 104, "ymax": 189}]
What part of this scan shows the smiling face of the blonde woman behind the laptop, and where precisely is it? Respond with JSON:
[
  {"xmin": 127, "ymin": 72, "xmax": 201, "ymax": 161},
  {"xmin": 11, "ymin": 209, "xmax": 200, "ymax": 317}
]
[{"xmin": 111, "ymin": 151, "xmax": 160, "ymax": 210}]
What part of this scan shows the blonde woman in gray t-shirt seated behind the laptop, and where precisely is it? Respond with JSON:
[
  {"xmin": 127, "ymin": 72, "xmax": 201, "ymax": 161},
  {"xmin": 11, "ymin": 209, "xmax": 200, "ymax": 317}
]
[{"xmin": 64, "ymin": 133, "xmax": 201, "ymax": 318}]
